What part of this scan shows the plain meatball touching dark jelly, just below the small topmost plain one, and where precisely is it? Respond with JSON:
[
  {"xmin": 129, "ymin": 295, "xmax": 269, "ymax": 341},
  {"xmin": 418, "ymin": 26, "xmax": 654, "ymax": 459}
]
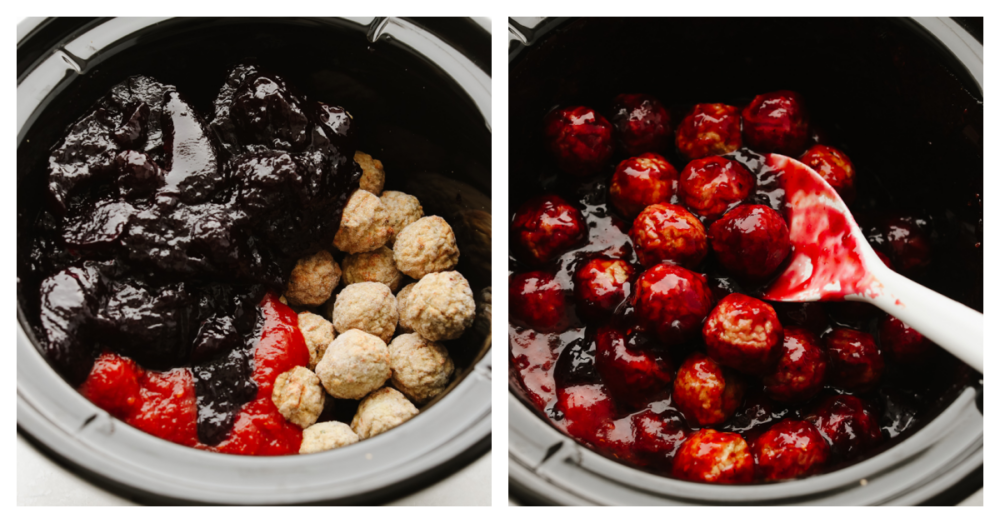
[{"xmin": 333, "ymin": 189, "xmax": 392, "ymax": 254}]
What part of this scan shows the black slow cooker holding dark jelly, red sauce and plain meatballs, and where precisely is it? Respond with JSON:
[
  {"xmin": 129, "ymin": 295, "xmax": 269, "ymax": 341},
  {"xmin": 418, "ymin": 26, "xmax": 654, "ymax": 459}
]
[{"xmin": 17, "ymin": 18, "xmax": 492, "ymax": 504}]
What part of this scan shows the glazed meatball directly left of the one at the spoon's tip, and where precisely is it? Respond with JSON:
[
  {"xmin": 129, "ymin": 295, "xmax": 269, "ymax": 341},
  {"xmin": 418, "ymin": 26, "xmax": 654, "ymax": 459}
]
[{"xmin": 608, "ymin": 153, "xmax": 677, "ymax": 219}]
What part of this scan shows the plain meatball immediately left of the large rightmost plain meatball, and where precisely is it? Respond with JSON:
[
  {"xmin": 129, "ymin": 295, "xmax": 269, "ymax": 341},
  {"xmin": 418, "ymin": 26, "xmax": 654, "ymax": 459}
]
[{"xmin": 333, "ymin": 282, "xmax": 399, "ymax": 343}]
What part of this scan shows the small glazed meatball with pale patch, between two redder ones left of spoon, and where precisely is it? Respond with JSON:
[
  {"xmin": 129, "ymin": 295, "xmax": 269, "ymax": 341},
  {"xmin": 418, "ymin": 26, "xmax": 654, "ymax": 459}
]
[{"xmin": 572, "ymin": 256, "xmax": 636, "ymax": 319}]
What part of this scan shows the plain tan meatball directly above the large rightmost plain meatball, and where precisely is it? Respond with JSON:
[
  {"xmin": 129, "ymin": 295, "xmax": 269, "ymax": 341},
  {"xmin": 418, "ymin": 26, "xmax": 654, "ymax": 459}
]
[{"xmin": 392, "ymin": 216, "xmax": 458, "ymax": 280}]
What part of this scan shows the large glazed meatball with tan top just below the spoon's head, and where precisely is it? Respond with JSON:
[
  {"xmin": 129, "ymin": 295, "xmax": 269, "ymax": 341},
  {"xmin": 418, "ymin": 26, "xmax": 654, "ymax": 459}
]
[{"xmin": 701, "ymin": 294, "xmax": 784, "ymax": 375}]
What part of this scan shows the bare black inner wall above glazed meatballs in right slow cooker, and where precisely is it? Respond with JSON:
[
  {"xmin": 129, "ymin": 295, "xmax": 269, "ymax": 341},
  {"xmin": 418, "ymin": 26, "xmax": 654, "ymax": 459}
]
[{"xmin": 509, "ymin": 18, "xmax": 983, "ymax": 506}]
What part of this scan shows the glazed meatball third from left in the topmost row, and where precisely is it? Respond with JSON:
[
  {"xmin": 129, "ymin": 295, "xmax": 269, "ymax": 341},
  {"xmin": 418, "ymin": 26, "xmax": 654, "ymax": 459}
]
[{"xmin": 676, "ymin": 104, "xmax": 743, "ymax": 160}]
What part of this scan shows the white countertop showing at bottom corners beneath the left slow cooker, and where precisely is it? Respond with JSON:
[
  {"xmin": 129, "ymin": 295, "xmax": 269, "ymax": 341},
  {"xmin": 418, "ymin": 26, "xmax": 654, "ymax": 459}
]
[{"xmin": 17, "ymin": 434, "xmax": 493, "ymax": 506}]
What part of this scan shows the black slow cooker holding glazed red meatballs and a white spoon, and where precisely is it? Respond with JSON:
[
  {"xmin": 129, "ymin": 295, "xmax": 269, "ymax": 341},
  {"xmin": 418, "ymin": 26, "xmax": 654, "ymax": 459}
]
[{"xmin": 508, "ymin": 18, "xmax": 983, "ymax": 505}]
